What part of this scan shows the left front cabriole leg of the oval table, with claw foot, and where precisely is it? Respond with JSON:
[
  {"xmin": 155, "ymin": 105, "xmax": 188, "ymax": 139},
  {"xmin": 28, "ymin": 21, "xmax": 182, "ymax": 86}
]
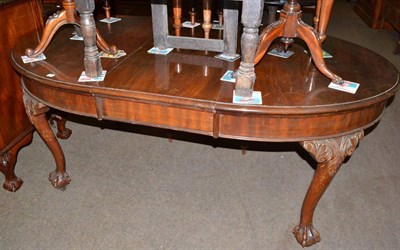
[{"xmin": 22, "ymin": 88, "xmax": 71, "ymax": 190}]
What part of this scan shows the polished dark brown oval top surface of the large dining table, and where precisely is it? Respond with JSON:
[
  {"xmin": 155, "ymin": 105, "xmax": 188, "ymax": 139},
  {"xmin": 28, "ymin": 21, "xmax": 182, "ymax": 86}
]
[{"xmin": 12, "ymin": 17, "xmax": 398, "ymax": 113}]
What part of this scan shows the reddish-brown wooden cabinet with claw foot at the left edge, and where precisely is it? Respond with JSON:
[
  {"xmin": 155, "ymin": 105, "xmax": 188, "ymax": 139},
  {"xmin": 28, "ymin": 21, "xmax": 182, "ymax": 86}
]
[{"xmin": 0, "ymin": 0, "xmax": 43, "ymax": 191}]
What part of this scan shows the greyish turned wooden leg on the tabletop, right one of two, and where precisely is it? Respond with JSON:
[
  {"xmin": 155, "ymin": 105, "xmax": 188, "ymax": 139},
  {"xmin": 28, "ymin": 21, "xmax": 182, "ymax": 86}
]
[{"xmin": 235, "ymin": 0, "xmax": 264, "ymax": 97}]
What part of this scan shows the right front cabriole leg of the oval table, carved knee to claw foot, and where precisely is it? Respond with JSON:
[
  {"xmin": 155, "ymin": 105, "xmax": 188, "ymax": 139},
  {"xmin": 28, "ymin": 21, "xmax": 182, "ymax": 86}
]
[{"xmin": 293, "ymin": 130, "xmax": 364, "ymax": 247}]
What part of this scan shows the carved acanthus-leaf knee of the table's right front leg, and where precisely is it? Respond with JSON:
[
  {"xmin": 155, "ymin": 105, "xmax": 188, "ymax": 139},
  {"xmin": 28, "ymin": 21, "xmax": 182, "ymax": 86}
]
[{"xmin": 300, "ymin": 130, "xmax": 364, "ymax": 176}]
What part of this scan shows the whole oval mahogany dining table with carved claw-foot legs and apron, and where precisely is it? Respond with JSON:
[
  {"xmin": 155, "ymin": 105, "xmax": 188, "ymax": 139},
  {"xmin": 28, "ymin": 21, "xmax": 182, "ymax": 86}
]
[{"xmin": 11, "ymin": 17, "xmax": 399, "ymax": 246}]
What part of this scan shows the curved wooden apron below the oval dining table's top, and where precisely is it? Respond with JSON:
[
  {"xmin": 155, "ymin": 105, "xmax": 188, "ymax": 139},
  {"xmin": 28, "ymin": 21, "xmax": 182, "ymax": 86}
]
[{"xmin": 23, "ymin": 78, "xmax": 387, "ymax": 142}]
